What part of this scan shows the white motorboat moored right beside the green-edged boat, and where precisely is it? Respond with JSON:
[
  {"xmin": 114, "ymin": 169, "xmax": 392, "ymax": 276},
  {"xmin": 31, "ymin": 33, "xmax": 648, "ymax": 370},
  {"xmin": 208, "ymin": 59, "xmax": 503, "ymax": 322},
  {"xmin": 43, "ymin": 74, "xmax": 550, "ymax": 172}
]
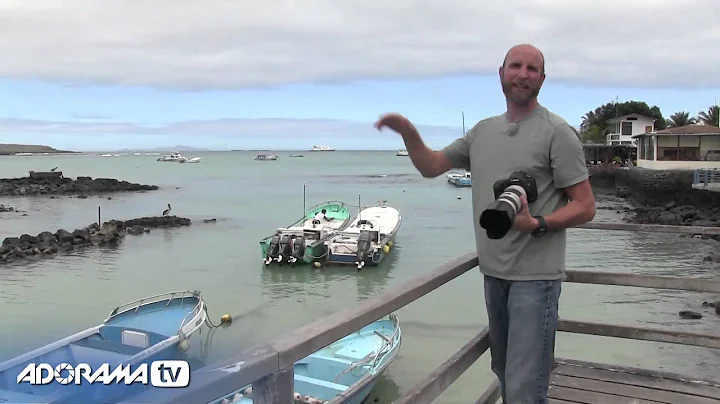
[{"xmin": 326, "ymin": 201, "xmax": 402, "ymax": 271}]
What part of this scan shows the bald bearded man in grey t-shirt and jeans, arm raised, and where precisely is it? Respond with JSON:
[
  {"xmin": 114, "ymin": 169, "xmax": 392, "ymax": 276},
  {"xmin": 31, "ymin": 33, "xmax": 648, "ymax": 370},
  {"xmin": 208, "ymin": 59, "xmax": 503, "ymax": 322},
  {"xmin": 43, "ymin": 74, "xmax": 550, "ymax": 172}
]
[{"xmin": 375, "ymin": 45, "xmax": 595, "ymax": 404}]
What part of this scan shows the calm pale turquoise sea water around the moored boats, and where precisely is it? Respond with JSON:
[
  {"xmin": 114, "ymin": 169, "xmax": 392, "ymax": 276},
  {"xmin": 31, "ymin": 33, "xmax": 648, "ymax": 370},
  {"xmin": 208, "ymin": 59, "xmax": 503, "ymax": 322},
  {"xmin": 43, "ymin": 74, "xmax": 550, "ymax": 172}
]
[{"xmin": 0, "ymin": 151, "xmax": 720, "ymax": 404}]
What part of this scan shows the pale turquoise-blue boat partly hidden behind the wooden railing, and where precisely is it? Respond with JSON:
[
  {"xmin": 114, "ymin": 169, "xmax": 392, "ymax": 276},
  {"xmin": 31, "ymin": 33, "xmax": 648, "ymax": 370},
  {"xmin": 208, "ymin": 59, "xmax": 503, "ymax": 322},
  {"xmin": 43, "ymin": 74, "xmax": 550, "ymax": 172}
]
[{"xmin": 208, "ymin": 314, "xmax": 402, "ymax": 404}]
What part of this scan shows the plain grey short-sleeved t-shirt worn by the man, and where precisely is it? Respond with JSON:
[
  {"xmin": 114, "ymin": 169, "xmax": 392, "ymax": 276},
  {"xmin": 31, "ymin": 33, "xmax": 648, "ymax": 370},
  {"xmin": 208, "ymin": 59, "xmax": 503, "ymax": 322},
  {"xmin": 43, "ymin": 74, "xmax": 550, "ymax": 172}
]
[{"xmin": 443, "ymin": 106, "xmax": 588, "ymax": 280}]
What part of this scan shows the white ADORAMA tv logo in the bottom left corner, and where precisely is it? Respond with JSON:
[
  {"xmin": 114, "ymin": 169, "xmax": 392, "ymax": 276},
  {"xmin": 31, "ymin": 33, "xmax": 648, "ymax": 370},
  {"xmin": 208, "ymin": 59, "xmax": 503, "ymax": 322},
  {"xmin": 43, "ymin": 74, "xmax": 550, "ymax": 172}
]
[{"xmin": 17, "ymin": 360, "xmax": 190, "ymax": 388}]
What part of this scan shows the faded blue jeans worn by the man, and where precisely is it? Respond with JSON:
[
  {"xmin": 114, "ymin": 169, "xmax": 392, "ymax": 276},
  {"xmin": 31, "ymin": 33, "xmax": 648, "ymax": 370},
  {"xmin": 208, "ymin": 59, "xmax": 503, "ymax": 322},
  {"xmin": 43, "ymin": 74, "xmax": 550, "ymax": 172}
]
[{"xmin": 485, "ymin": 276, "xmax": 562, "ymax": 404}]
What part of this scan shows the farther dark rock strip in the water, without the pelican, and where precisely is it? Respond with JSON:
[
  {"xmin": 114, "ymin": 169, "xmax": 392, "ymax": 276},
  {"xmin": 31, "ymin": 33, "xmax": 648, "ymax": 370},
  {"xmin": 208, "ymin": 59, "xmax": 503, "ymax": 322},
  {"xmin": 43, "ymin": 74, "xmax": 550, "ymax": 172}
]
[{"xmin": 0, "ymin": 176, "xmax": 159, "ymax": 196}]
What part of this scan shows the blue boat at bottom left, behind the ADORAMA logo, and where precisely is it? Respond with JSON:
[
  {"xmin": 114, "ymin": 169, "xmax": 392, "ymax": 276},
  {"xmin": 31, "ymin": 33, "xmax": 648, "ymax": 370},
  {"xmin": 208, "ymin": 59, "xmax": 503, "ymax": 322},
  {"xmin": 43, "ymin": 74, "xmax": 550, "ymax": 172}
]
[{"xmin": 0, "ymin": 291, "xmax": 207, "ymax": 404}]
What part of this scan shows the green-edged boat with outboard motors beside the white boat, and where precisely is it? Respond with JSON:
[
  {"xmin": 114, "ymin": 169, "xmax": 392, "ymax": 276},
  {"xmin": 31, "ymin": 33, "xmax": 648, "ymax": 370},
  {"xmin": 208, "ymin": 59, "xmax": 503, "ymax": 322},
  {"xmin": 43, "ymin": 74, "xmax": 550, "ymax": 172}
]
[{"xmin": 260, "ymin": 201, "xmax": 351, "ymax": 265}]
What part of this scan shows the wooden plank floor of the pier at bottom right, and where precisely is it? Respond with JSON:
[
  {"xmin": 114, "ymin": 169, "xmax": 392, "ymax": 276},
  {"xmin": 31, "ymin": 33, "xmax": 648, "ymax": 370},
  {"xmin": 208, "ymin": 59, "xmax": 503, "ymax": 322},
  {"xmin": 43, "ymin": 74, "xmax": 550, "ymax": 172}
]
[{"xmin": 548, "ymin": 359, "xmax": 720, "ymax": 404}]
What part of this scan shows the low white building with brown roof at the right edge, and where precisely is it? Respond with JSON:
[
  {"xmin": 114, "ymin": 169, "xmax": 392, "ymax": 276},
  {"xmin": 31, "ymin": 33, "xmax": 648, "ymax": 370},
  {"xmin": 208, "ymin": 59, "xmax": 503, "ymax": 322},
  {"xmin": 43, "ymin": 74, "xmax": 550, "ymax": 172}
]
[{"xmin": 633, "ymin": 125, "xmax": 720, "ymax": 170}]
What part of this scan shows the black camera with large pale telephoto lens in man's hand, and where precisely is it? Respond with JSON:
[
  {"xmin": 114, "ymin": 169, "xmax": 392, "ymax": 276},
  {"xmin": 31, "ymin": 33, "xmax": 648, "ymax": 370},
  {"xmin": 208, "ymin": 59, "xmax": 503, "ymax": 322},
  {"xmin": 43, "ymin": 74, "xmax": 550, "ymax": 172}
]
[{"xmin": 480, "ymin": 171, "xmax": 538, "ymax": 240}]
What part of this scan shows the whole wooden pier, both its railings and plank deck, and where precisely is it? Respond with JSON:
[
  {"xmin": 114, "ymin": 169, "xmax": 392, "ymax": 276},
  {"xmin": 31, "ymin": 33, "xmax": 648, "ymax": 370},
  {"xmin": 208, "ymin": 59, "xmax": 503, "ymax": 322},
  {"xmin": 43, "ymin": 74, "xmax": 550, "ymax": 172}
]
[{"xmin": 134, "ymin": 222, "xmax": 720, "ymax": 404}]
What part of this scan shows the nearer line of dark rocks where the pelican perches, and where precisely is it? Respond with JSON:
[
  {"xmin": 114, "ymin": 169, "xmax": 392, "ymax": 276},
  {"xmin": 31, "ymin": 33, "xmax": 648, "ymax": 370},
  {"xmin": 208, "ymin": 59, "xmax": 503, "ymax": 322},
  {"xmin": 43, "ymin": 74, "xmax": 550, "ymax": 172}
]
[{"xmin": 0, "ymin": 216, "xmax": 191, "ymax": 265}]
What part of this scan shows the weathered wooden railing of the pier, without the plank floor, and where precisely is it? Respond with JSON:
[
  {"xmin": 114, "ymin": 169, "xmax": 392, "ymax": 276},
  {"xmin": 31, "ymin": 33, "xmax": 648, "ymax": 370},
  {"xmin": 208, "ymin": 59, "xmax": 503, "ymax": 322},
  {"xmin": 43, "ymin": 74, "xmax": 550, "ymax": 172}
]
[{"xmin": 148, "ymin": 223, "xmax": 720, "ymax": 404}]
